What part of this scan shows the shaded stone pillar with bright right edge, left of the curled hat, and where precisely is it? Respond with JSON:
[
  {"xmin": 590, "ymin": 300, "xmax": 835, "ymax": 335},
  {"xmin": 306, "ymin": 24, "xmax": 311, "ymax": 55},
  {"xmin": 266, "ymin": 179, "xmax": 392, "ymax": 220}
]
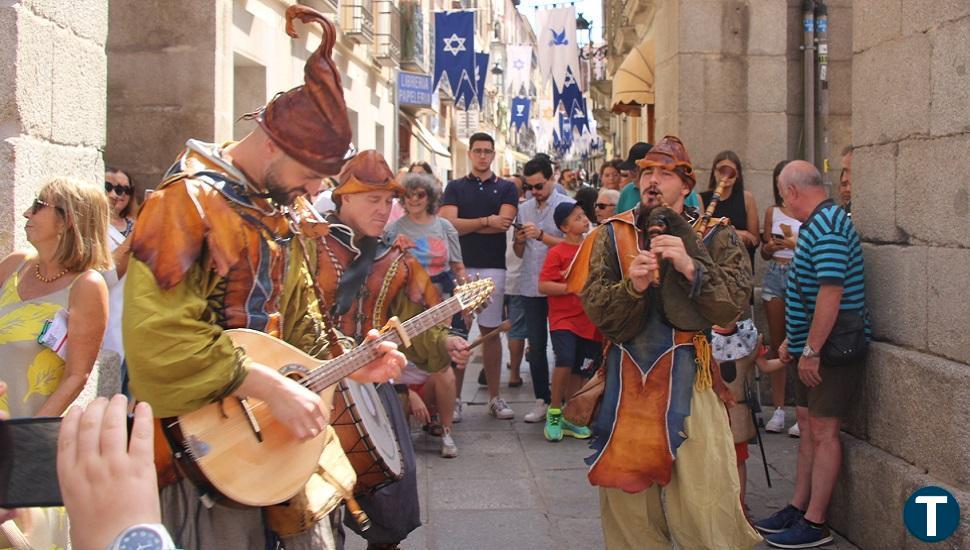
[{"xmin": 105, "ymin": 0, "xmax": 233, "ymax": 194}]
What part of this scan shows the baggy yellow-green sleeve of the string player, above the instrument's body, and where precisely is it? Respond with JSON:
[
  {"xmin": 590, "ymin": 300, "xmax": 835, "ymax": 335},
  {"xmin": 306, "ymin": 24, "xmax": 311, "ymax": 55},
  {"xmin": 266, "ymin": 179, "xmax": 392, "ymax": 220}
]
[{"xmin": 122, "ymin": 258, "xmax": 249, "ymax": 418}]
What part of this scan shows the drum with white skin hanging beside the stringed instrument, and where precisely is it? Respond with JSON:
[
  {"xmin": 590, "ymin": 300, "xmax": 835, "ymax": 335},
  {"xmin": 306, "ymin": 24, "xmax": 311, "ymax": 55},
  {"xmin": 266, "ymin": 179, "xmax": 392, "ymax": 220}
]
[{"xmin": 331, "ymin": 379, "xmax": 404, "ymax": 494}]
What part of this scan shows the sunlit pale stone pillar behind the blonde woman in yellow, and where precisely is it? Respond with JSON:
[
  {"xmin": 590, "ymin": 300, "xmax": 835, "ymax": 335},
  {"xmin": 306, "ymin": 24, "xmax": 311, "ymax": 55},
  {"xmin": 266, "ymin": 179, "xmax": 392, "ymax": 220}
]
[{"xmin": 0, "ymin": 0, "xmax": 108, "ymax": 255}]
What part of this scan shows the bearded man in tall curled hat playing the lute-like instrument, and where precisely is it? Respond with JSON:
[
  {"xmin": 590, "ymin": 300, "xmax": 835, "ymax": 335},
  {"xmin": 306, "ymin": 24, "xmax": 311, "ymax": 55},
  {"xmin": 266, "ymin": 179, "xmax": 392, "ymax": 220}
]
[{"xmin": 123, "ymin": 6, "xmax": 405, "ymax": 550}]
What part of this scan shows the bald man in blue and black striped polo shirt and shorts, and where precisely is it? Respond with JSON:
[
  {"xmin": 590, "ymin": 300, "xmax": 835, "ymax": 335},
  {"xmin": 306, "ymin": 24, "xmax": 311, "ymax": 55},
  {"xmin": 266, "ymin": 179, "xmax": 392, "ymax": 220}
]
[{"xmin": 755, "ymin": 161, "xmax": 868, "ymax": 548}]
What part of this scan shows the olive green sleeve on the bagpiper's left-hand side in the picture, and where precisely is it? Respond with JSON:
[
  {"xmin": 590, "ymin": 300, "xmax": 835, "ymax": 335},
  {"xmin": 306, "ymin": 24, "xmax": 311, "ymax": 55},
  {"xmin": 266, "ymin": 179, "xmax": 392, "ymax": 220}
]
[{"xmin": 581, "ymin": 228, "xmax": 648, "ymax": 342}]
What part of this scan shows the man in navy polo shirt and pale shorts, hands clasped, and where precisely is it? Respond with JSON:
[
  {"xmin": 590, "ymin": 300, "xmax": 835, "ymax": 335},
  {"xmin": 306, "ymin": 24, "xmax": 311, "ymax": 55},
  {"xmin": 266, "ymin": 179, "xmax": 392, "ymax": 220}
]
[{"xmin": 439, "ymin": 132, "xmax": 519, "ymax": 421}]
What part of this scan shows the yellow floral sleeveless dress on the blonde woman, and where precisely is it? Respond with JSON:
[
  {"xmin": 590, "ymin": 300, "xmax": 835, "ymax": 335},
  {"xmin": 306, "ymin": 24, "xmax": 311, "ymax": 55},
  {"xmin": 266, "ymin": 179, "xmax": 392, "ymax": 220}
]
[{"xmin": 0, "ymin": 265, "xmax": 73, "ymax": 550}]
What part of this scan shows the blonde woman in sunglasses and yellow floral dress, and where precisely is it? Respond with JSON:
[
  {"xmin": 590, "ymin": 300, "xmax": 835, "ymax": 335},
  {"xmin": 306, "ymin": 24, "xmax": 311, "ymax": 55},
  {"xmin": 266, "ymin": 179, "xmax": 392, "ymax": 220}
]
[{"xmin": 0, "ymin": 178, "xmax": 111, "ymax": 548}]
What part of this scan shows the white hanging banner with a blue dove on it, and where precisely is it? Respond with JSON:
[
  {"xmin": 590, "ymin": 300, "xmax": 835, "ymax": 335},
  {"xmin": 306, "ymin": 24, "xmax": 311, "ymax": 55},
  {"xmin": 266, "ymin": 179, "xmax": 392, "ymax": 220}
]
[{"xmin": 536, "ymin": 6, "xmax": 579, "ymax": 90}]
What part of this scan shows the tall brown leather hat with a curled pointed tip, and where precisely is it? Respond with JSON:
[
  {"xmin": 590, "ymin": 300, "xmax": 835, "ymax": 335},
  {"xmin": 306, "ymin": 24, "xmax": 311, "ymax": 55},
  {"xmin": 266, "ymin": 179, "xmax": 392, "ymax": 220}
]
[{"xmin": 257, "ymin": 4, "xmax": 353, "ymax": 175}]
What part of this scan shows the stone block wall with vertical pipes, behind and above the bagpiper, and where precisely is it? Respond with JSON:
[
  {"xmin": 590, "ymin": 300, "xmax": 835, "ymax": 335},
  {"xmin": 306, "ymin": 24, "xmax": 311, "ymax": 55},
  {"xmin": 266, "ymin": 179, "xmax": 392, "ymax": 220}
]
[{"xmin": 651, "ymin": 0, "xmax": 852, "ymax": 229}]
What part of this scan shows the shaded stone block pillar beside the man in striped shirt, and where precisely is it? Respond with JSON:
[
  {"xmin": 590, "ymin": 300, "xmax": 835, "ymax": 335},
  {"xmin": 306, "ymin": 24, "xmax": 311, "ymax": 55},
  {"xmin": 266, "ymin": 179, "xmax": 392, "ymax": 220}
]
[{"xmin": 829, "ymin": 0, "xmax": 970, "ymax": 548}]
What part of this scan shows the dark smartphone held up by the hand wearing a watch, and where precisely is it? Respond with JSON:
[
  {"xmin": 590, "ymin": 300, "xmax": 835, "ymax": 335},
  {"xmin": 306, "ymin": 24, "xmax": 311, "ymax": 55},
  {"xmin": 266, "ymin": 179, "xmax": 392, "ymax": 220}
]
[{"xmin": 0, "ymin": 417, "xmax": 64, "ymax": 509}]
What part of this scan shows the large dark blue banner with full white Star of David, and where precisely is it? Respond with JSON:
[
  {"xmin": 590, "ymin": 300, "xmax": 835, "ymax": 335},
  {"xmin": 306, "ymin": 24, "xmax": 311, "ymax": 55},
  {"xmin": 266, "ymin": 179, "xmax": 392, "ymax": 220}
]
[{"xmin": 432, "ymin": 11, "xmax": 475, "ymax": 101}]
